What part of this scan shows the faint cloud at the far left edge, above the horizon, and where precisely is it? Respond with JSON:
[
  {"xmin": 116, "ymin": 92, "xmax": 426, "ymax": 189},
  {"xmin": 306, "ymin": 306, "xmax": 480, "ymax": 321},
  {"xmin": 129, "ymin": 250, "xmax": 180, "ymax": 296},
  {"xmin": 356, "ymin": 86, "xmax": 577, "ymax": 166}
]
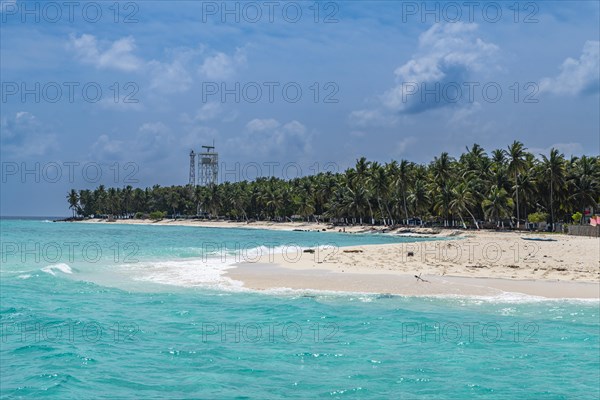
[{"xmin": 0, "ymin": 111, "xmax": 58, "ymax": 158}]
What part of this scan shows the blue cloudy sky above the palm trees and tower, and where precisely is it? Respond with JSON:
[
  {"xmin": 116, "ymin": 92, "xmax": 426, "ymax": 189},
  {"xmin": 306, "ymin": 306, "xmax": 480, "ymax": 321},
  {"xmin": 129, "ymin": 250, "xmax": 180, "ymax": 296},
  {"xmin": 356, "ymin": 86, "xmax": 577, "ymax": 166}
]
[{"xmin": 0, "ymin": 0, "xmax": 600, "ymax": 215}]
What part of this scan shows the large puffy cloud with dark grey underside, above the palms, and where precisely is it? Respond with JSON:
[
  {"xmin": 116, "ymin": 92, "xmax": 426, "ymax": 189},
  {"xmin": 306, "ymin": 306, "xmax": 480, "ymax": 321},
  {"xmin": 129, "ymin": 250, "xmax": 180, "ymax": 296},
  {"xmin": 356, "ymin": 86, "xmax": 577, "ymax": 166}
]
[{"xmin": 382, "ymin": 23, "xmax": 499, "ymax": 114}]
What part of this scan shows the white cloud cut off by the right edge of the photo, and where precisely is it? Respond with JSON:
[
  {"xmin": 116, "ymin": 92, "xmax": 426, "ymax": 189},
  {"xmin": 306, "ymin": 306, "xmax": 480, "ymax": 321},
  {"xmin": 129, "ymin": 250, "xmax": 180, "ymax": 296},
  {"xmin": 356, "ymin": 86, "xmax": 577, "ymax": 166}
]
[{"xmin": 540, "ymin": 41, "xmax": 600, "ymax": 95}]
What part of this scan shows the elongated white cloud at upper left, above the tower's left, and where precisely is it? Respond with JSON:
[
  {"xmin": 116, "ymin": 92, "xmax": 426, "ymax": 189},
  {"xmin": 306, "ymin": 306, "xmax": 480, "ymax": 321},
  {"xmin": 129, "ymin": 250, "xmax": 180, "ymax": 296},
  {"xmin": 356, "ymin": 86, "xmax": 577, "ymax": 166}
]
[{"xmin": 68, "ymin": 34, "xmax": 142, "ymax": 71}]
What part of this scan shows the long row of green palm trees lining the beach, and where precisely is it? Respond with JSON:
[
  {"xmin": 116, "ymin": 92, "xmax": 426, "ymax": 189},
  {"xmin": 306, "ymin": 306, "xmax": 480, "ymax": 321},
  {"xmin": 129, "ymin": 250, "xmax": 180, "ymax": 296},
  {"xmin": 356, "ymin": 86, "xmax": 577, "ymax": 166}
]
[{"xmin": 67, "ymin": 141, "xmax": 600, "ymax": 228}]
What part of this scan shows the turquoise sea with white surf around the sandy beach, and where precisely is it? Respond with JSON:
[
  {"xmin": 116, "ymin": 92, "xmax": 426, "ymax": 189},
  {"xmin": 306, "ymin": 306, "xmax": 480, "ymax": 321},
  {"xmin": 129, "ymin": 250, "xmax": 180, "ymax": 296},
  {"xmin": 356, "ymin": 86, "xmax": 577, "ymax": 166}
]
[{"xmin": 0, "ymin": 219, "xmax": 600, "ymax": 399}]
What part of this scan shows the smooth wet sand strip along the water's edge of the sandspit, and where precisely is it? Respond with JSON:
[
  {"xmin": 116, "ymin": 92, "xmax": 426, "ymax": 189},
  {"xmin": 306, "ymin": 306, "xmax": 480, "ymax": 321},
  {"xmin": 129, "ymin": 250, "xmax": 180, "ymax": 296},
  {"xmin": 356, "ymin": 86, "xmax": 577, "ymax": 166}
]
[{"xmin": 225, "ymin": 263, "xmax": 600, "ymax": 300}]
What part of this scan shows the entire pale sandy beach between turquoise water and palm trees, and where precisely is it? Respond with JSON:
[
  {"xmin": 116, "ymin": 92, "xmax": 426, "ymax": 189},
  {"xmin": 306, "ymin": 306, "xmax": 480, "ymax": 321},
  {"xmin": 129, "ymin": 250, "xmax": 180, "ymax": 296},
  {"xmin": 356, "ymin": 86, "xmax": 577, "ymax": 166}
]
[{"xmin": 71, "ymin": 220, "xmax": 600, "ymax": 299}]
